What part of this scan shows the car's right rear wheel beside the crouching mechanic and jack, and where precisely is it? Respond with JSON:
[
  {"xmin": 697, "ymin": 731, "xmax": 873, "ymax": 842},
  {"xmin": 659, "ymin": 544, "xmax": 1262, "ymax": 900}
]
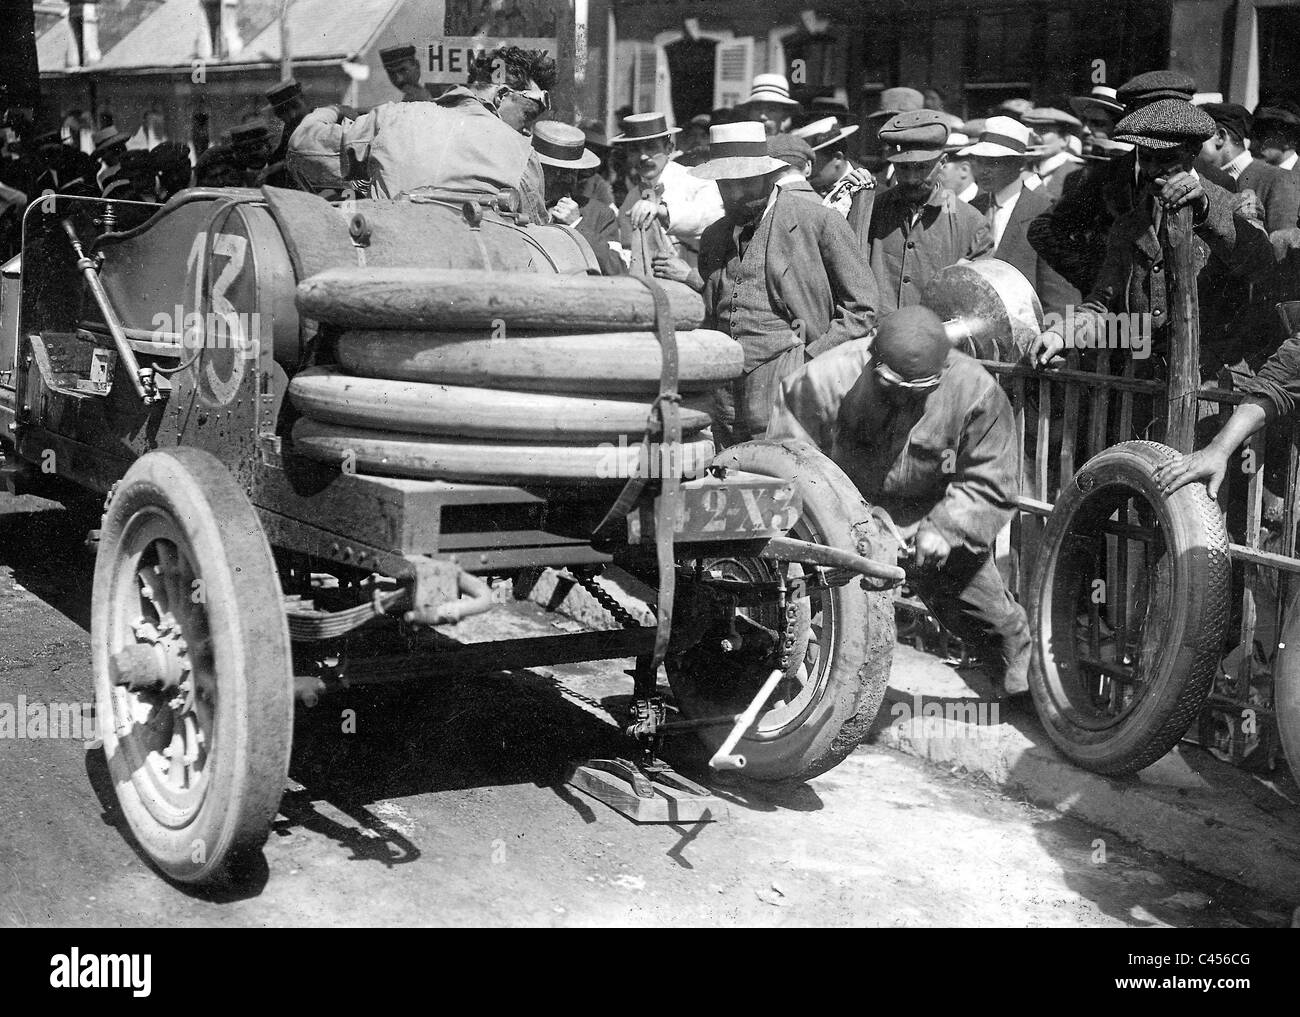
[{"xmin": 667, "ymin": 442, "xmax": 894, "ymax": 780}]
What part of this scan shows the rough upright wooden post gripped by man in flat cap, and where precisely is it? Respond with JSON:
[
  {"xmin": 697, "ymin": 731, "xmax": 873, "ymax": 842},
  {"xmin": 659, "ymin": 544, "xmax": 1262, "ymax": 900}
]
[{"xmin": 1153, "ymin": 205, "xmax": 1201, "ymax": 453}]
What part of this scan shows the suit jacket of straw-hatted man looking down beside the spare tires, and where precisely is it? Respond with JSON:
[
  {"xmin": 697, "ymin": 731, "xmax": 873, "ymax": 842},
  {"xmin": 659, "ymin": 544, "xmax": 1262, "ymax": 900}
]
[{"xmin": 699, "ymin": 192, "xmax": 880, "ymax": 356}]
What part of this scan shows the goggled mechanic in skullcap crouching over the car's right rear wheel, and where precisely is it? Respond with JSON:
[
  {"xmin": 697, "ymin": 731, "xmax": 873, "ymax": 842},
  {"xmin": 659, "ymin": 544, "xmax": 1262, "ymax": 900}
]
[{"xmin": 767, "ymin": 307, "xmax": 1030, "ymax": 696}]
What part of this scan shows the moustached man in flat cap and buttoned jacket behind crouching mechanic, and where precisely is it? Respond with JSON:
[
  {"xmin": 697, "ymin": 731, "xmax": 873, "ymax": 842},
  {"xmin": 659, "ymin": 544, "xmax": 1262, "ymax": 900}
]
[{"xmin": 866, "ymin": 109, "xmax": 993, "ymax": 312}]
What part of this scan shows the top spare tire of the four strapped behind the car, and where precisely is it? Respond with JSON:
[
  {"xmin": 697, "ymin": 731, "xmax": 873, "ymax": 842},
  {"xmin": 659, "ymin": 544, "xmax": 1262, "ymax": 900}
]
[{"xmin": 296, "ymin": 268, "xmax": 705, "ymax": 330}]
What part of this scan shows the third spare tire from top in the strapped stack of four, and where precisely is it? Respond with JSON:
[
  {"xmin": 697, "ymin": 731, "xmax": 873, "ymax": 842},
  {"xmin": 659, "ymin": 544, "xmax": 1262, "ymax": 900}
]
[{"xmin": 289, "ymin": 367, "xmax": 710, "ymax": 443}]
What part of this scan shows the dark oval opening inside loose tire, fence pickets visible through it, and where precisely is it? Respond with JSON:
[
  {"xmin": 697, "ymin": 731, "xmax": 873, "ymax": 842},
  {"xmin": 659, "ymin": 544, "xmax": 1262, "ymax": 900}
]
[{"xmin": 1047, "ymin": 484, "xmax": 1178, "ymax": 731}]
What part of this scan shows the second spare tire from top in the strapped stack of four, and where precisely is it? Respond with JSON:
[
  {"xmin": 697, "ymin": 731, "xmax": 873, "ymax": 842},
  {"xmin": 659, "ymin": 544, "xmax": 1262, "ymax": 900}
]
[{"xmin": 337, "ymin": 329, "xmax": 745, "ymax": 398}]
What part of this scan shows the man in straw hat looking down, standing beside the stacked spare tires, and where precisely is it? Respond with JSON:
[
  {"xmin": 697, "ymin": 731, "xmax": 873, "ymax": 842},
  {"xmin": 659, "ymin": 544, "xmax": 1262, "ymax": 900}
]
[{"xmin": 690, "ymin": 121, "xmax": 879, "ymax": 447}]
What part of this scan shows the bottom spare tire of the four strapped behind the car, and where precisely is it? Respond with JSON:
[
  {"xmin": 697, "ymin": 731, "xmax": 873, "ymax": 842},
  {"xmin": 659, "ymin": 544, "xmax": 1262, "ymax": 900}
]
[{"xmin": 294, "ymin": 417, "xmax": 714, "ymax": 484}]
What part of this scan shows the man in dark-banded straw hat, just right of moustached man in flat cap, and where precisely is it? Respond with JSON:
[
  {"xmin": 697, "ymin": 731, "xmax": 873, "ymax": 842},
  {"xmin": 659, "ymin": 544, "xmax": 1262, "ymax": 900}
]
[{"xmin": 959, "ymin": 117, "xmax": 1079, "ymax": 315}]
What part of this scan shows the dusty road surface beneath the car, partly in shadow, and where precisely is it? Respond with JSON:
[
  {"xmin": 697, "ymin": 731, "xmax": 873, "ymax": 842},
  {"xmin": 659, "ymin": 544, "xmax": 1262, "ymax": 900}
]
[{"xmin": 0, "ymin": 495, "xmax": 1288, "ymax": 927}]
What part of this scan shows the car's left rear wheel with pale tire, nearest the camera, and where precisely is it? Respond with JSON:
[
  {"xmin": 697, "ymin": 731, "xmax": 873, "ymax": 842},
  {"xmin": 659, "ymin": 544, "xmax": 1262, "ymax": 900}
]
[{"xmin": 91, "ymin": 449, "xmax": 293, "ymax": 883}]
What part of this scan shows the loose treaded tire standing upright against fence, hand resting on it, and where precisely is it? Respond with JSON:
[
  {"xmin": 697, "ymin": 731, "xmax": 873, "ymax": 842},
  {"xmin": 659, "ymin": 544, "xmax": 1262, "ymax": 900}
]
[{"xmin": 1030, "ymin": 441, "xmax": 1230, "ymax": 775}]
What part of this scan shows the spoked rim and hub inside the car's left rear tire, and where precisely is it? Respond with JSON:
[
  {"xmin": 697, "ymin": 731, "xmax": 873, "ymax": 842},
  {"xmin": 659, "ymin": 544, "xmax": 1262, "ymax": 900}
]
[{"xmin": 108, "ymin": 509, "xmax": 217, "ymax": 827}]
